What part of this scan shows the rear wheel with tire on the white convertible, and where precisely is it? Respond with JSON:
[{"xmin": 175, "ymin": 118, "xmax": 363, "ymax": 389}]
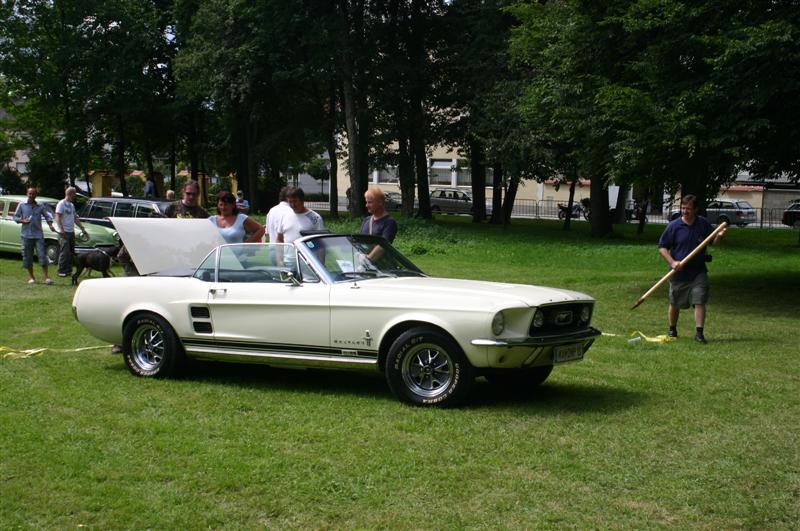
[{"xmin": 122, "ymin": 313, "xmax": 185, "ymax": 378}]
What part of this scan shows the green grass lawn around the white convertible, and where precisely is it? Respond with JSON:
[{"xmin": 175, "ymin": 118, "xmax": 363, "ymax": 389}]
[{"xmin": 0, "ymin": 216, "xmax": 800, "ymax": 529}]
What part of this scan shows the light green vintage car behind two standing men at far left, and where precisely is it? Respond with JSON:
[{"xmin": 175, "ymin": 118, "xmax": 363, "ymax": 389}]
[{"xmin": 0, "ymin": 195, "xmax": 119, "ymax": 263}]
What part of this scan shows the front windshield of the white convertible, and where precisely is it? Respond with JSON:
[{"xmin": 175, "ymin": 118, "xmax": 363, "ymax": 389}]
[{"xmin": 300, "ymin": 235, "xmax": 425, "ymax": 282}]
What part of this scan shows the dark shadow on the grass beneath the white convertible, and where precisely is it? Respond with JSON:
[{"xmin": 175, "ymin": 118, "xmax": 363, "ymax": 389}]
[{"xmin": 108, "ymin": 361, "xmax": 646, "ymax": 415}]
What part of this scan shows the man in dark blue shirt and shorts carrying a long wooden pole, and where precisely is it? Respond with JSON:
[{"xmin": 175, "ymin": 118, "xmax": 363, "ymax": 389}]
[{"xmin": 658, "ymin": 195, "xmax": 725, "ymax": 343}]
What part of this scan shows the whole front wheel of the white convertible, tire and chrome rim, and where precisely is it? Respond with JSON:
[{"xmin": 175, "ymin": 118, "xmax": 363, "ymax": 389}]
[{"xmin": 386, "ymin": 327, "xmax": 475, "ymax": 407}]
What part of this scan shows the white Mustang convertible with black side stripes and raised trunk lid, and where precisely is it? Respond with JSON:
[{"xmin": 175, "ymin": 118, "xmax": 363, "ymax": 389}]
[{"xmin": 72, "ymin": 218, "xmax": 600, "ymax": 405}]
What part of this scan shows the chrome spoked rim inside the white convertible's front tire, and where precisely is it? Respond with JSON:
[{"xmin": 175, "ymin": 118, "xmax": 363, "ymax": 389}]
[{"xmin": 401, "ymin": 343, "xmax": 455, "ymax": 398}]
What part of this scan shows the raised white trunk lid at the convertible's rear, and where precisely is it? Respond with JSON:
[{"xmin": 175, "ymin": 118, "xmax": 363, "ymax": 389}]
[{"xmin": 109, "ymin": 218, "xmax": 225, "ymax": 275}]
